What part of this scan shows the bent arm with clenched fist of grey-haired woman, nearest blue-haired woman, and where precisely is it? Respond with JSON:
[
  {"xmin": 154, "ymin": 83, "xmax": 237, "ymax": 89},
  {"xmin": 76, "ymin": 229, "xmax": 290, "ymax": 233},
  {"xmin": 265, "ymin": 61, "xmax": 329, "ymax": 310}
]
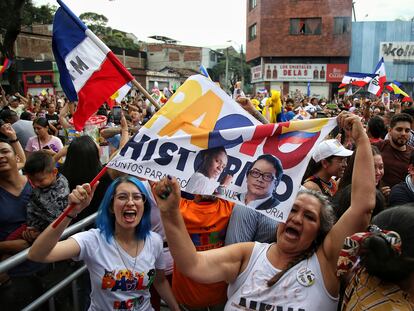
[{"xmin": 154, "ymin": 178, "xmax": 254, "ymax": 283}]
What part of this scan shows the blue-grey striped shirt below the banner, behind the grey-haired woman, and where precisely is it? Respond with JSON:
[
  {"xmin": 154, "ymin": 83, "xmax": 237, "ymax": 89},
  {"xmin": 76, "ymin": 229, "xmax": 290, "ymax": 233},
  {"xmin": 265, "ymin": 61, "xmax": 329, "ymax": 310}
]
[{"xmin": 225, "ymin": 204, "xmax": 278, "ymax": 245}]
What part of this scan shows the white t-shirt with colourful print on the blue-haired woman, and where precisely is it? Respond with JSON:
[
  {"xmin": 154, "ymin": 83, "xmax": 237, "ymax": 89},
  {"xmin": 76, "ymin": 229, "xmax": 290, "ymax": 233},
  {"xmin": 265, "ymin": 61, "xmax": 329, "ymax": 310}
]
[{"xmin": 72, "ymin": 229, "xmax": 165, "ymax": 311}]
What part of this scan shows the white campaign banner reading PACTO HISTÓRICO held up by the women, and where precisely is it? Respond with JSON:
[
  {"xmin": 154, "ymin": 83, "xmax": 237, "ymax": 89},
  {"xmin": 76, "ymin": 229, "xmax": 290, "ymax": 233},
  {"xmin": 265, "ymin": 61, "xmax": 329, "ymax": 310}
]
[{"xmin": 108, "ymin": 75, "xmax": 336, "ymax": 222}]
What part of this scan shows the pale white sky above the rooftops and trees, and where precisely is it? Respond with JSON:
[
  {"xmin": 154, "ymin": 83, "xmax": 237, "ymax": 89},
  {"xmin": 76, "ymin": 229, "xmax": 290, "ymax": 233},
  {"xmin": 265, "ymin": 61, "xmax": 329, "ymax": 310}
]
[{"xmin": 32, "ymin": 0, "xmax": 414, "ymax": 50}]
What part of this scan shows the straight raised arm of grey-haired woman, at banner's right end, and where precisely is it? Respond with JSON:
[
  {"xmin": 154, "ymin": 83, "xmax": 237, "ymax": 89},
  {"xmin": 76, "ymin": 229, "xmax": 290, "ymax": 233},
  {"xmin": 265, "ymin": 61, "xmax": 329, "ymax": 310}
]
[{"xmin": 318, "ymin": 113, "xmax": 375, "ymax": 286}]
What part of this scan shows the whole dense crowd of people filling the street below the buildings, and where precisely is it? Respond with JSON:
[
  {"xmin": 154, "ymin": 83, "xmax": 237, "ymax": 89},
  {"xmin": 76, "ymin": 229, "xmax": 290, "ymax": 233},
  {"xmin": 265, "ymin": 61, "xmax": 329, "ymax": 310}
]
[{"xmin": 0, "ymin": 84, "xmax": 414, "ymax": 311}]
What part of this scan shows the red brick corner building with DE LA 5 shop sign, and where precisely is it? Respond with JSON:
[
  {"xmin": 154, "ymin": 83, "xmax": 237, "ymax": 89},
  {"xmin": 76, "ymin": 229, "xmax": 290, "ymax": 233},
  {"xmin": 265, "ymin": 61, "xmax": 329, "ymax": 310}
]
[{"xmin": 246, "ymin": 0, "xmax": 352, "ymax": 97}]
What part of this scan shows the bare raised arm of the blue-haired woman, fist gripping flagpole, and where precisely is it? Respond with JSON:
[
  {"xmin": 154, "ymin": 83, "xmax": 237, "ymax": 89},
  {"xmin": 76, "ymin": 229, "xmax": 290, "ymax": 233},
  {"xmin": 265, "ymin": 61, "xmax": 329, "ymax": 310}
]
[{"xmin": 28, "ymin": 182, "xmax": 99, "ymax": 262}]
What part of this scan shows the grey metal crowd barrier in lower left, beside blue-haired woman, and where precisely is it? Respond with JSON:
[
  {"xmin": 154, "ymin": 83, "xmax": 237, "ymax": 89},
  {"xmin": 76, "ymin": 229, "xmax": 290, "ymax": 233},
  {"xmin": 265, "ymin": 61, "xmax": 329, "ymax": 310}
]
[{"xmin": 0, "ymin": 212, "xmax": 98, "ymax": 311}]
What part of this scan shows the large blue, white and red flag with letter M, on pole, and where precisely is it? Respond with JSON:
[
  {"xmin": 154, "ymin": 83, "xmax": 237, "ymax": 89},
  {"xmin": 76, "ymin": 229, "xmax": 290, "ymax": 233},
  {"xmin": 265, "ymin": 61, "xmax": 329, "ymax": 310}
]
[{"xmin": 52, "ymin": 0, "xmax": 134, "ymax": 131}]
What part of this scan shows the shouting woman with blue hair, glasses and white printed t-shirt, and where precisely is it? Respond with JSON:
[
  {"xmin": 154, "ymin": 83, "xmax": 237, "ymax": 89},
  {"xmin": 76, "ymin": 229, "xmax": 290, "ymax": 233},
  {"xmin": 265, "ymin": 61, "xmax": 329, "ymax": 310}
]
[{"xmin": 29, "ymin": 176, "xmax": 178, "ymax": 310}]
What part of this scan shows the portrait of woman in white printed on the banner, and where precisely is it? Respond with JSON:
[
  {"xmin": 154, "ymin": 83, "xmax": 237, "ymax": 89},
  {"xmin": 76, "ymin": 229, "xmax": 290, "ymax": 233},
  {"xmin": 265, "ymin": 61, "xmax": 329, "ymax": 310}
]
[{"xmin": 184, "ymin": 147, "xmax": 233, "ymax": 195}]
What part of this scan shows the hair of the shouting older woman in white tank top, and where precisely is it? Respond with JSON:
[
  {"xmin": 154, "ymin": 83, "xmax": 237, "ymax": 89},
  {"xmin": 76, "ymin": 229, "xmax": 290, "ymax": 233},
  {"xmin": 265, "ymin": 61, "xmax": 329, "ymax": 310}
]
[{"xmin": 267, "ymin": 189, "xmax": 335, "ymax": 287}]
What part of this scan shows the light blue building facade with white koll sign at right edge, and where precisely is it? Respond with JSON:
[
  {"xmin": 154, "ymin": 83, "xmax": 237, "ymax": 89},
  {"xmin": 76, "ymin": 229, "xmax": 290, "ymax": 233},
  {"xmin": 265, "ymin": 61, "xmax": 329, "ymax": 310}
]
[{"xmin": 349, "ymin": 20, "xmax": 414, "ymax": 95}]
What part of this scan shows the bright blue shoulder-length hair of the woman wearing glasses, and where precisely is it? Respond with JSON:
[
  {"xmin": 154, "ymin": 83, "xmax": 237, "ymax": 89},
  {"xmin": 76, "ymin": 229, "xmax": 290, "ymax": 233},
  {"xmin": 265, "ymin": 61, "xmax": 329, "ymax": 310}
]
[{"xmin": 96, "ymin": 176, "xmax": 151, "ymax": 243}]
